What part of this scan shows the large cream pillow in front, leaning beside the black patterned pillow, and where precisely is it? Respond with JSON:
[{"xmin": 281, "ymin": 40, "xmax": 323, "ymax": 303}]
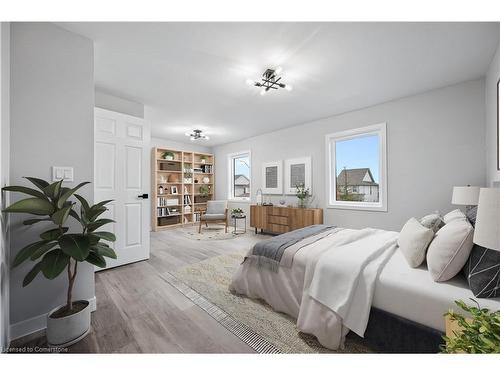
[{"xmin": 427, "ymin": 219, "xmax": 474, "ymax": 281}]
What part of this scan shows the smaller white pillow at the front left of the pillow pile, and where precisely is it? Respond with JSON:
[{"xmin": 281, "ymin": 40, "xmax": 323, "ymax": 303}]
[{"xmin": 398, "ymin": 217, "xmax": 434, "ymax": 268}]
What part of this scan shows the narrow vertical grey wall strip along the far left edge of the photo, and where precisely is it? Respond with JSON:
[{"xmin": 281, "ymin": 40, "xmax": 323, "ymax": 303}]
[{"xmin": 0, "ymin": 22, "xmax": 10, "ymax": 352}]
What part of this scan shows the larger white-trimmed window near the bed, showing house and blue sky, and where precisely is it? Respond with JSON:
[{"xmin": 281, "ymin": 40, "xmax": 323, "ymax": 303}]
[{"xmin": 326, "ymin": 123, "xmax": 387, "ymax": 211}]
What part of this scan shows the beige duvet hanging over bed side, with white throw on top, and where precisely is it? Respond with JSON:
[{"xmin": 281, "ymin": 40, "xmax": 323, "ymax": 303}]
[{"xmin": 230, "ymin": 228, "xmax": 397, "ymax": 349}]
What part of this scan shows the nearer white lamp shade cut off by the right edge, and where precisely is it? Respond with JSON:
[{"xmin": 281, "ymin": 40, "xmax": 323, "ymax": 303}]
[{"xmin": 474, "ymin": 188, "xmax": 500, "ymax": 251}]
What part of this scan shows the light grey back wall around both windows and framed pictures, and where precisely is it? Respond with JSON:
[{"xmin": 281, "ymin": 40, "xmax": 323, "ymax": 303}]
[{"xmin": 214, "ymin": 80, "xmax": 486, "ymax": 230}]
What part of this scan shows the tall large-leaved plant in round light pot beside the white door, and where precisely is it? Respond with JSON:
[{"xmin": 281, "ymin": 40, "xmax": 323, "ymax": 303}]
[{"xmin": 2, "ymin": 177, "xmax": 116, "ymax": 346}]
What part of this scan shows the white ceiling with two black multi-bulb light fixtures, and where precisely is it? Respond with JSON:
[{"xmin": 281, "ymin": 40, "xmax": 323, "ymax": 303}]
[{"xmin": 59, "ymin": 23, "xmax": 500, "ymax": 146}]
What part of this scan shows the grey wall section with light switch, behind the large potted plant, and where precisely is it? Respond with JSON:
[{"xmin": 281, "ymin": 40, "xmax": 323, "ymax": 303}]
[{"xmin": 10, "ymin": 23, "xmax": 95, "ymax": 339}]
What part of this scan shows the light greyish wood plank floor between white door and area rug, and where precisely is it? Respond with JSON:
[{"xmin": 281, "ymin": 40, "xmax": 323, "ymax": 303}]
[{"xmin": 13, "ymin": 228, "xmax": 266, "ymax": 353}]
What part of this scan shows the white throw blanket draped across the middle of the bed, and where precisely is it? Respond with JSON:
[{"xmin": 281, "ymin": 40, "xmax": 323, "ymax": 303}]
[{"xmin": 299, "ymin": 228, "xmax": 397, "ymax": 336}]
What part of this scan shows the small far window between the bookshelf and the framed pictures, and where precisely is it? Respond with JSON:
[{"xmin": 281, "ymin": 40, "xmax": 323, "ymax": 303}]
[{"xmin": 228, "ymin": 151, "xmax": 250, "ymax": 200}]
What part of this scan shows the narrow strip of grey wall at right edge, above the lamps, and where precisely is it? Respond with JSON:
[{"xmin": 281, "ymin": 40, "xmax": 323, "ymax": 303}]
[{"xmin": 485, "ymin": 40, "xmax": 500, "ymax": 186}]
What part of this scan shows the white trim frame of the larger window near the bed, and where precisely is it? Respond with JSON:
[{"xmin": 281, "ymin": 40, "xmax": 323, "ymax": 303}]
[{"xmin": 325, "ymin": 122, "xmax": 387, "ymax": 212}]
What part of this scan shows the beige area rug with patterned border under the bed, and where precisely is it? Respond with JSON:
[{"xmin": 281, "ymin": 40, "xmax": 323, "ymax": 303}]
[{"xmin": 167, "ymin": 254, "xmax": 371, "ymax": 353}]
